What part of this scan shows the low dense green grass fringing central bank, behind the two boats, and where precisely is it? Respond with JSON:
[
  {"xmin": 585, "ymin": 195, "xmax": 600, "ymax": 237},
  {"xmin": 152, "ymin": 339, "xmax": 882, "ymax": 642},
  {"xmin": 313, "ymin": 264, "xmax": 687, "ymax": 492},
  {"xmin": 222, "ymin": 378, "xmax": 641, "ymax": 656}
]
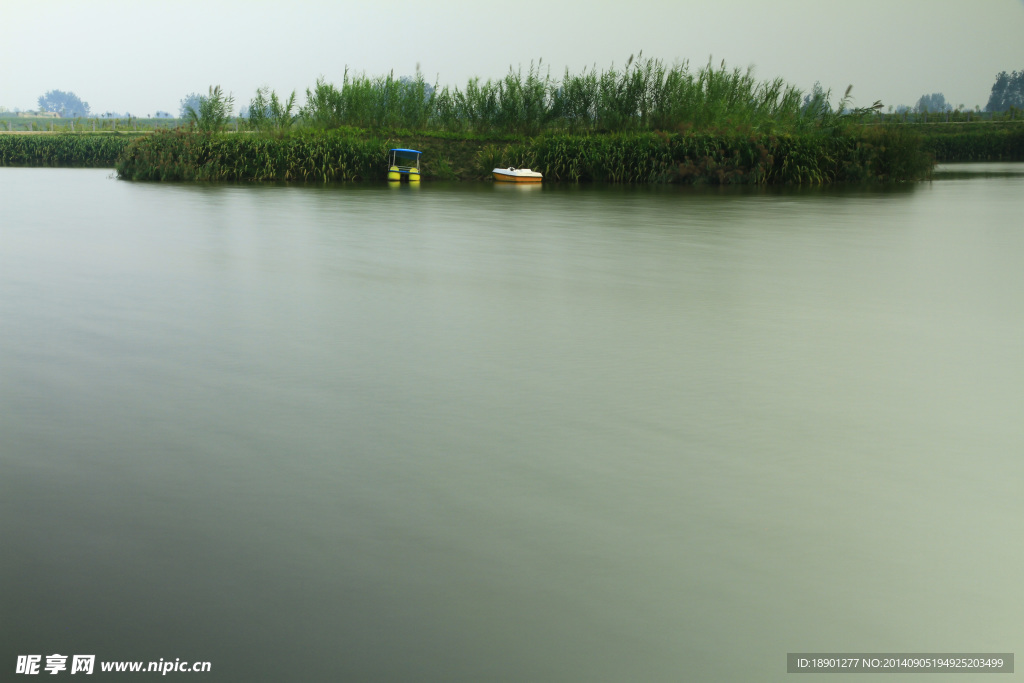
[{"xmin": 117, "ymin": 127, "xmax": 932, "ymax": 184}]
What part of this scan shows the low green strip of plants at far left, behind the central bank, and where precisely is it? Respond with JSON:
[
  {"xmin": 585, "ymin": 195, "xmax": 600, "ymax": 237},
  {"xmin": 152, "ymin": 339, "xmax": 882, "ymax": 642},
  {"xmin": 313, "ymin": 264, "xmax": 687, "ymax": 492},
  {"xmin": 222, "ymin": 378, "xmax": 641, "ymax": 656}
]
[{"xmin": 0, "ymin": 133, "xmax": 135, "ymax": 168}]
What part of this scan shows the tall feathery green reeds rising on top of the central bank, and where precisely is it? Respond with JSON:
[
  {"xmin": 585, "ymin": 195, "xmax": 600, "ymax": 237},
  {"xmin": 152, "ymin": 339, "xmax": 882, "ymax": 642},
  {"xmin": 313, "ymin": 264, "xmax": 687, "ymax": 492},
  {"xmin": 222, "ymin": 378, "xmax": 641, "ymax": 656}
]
[{"xmin": 294, "ymin": 55, "xmax": 820, "ymax": 135}]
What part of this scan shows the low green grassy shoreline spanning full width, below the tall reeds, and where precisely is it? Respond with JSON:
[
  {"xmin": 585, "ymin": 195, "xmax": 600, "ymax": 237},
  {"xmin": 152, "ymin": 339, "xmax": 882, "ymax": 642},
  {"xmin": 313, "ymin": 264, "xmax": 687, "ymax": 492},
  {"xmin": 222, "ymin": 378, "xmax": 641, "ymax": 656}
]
[{"xmin": 0, "ymin": 123, "xmax": 1024, "ymax": 184}]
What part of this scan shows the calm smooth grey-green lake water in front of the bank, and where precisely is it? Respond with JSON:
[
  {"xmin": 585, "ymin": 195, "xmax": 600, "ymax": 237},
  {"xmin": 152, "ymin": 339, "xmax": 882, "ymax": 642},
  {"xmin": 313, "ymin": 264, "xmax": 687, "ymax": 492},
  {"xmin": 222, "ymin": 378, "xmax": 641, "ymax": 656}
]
[{"xmin": 0, "ymin": 165, "xmax": 1024, "ymax": 682}]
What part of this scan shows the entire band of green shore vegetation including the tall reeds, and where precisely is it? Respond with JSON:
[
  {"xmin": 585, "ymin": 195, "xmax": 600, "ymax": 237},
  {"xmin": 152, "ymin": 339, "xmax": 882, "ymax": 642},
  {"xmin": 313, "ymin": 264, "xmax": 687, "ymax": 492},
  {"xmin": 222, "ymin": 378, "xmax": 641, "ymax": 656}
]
[{"xmin": 0, "ymin": 56, "xmax": 1024, "ymax": 185}]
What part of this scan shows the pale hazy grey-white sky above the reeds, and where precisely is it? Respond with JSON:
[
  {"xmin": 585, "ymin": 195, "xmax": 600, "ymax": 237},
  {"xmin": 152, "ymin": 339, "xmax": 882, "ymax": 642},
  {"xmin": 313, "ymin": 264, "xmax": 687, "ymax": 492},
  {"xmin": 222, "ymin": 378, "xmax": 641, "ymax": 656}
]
[{"xmin": 0, "ymin": 0, "xmax": 1024, "ymax": 116}]
